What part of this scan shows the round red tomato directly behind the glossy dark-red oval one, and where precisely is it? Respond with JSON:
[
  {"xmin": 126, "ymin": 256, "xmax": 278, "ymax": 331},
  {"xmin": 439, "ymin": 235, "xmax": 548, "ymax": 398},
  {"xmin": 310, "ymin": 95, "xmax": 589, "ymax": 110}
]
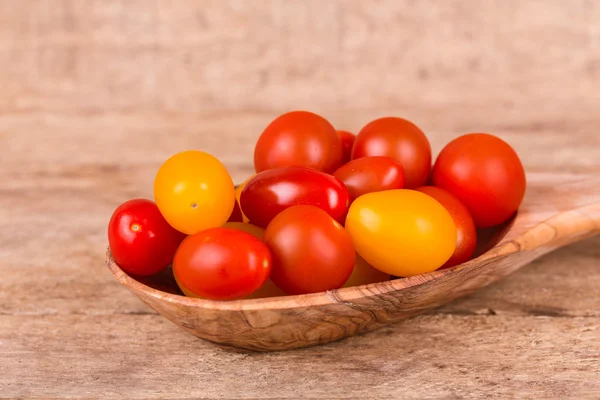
[{"xmin": 254, "ymin": 111, "xmax": 342, "ymax": 173}]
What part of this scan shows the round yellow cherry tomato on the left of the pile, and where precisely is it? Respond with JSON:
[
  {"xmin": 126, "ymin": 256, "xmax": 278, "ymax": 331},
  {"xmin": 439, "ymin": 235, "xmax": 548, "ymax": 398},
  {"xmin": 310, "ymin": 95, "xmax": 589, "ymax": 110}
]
[{"xmin": 154, "ymin": 150, "xmax": 235, "ymax": 235}]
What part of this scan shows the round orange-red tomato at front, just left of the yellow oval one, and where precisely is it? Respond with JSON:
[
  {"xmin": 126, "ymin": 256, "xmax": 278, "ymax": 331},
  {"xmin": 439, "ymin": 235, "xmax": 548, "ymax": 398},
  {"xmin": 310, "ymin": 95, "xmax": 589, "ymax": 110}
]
[{"xmin": 265, "ymin": 206, "xmax": 356, "ymax": 294}]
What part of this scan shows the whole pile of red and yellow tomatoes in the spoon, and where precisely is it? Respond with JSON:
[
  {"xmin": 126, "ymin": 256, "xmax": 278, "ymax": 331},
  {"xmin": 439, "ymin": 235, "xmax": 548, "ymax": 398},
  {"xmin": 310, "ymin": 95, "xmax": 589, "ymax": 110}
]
[{"xmin": 108, "ymin": 111, "xmax": 525, "ymax": 300}]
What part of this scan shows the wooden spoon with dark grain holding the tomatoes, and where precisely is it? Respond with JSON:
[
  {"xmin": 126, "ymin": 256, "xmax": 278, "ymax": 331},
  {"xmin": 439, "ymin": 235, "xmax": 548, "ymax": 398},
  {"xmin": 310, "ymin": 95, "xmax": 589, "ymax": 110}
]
[{"xmin": 107, "ymin": 174, "xmax": 600, "ymax": 351}]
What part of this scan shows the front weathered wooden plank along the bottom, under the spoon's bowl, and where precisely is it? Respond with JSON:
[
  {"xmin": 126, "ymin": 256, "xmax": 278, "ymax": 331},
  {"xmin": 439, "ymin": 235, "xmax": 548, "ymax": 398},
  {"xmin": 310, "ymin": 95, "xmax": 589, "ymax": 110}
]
[{"xmin": 0, "ymin": 315, "xmax": 600, "ymax": 399}]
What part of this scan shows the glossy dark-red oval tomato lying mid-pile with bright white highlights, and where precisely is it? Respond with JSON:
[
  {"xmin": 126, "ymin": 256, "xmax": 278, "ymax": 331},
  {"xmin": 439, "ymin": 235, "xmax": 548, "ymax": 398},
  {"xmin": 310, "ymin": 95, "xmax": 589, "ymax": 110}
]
[{"xmin": 240, "ymin": 167, "xmax": 350, "ymax": 228}]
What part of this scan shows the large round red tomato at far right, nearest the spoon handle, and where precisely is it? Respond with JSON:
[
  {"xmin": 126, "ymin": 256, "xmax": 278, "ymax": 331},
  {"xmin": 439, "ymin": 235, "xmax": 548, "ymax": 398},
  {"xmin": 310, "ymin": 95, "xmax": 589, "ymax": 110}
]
[{"xmin": 433, "ymin": 133, "xmax": 526, "ymax": 228}]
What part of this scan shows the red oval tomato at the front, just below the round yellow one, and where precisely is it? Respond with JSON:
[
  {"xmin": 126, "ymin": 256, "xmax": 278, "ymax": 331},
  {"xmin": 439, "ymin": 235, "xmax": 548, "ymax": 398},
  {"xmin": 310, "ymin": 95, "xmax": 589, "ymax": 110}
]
[{"xmin": 173, "ymin": 228, "xmax": 271, "ymax": 300}]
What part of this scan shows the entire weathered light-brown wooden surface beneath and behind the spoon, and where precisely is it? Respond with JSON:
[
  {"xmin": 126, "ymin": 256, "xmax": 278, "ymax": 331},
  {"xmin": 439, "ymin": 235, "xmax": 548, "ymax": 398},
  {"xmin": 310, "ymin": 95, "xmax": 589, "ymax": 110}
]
[{"xmin": 0, "ymin": 0, "xmax": 600, "ymax": 399}]
